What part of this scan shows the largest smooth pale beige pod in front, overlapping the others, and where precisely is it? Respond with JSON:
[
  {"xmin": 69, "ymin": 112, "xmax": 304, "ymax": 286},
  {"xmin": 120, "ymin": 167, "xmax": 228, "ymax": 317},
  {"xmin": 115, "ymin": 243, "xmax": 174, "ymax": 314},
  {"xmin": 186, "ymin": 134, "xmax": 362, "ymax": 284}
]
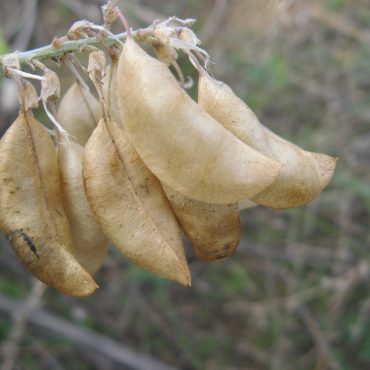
[{"xmin": 117, "ymin": 38, "xmax": 281, "ymax": 203}]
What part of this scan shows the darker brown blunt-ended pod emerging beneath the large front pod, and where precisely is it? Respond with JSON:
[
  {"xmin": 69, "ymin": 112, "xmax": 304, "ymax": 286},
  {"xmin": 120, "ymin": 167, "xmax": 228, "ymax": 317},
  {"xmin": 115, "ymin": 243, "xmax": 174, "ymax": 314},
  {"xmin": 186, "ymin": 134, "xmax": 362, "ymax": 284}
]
[{"xmin": 163, "ymin": 185, "xmax": 240, "ymax": 261}]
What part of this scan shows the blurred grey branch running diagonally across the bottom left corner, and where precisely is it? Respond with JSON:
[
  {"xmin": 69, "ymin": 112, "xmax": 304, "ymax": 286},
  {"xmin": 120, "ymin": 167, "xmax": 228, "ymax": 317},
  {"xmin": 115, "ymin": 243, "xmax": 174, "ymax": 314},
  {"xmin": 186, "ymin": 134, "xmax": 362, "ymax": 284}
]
[{"xmin": 0, "ymin": 295, "xmax": 176, "ymax": 370}]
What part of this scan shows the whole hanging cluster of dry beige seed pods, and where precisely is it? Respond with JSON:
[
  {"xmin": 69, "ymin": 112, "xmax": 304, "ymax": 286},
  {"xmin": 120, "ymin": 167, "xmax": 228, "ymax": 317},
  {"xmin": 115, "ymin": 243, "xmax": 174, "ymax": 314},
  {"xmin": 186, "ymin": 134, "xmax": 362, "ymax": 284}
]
[{"xmin": 0, "ymin": 17, "xmax": 336, "ymax": 296}]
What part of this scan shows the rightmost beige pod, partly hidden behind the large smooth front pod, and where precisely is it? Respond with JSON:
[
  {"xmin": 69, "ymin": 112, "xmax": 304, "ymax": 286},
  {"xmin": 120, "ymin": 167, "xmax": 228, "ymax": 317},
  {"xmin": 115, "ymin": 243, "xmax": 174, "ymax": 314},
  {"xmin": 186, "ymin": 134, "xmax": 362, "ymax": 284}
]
[{"xmin": 198, "ymin": 75, "xmax": 336, "ymax": 208}]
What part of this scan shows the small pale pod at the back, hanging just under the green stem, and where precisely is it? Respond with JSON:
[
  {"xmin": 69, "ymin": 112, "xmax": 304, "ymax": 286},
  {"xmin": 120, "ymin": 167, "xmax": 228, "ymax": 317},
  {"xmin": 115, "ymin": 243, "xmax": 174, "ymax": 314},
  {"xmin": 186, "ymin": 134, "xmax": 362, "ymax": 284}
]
[{"xmin": 57, "ymin": 82, "xmax": 101, "ymax": 145}]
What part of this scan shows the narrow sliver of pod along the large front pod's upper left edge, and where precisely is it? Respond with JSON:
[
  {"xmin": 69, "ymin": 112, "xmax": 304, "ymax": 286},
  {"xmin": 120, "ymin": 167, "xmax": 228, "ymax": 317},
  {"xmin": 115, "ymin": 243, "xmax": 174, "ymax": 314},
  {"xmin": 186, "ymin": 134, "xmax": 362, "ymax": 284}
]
[{"xmin": 103, "ymin": 57, "xmax": 123, "ymax": 128}]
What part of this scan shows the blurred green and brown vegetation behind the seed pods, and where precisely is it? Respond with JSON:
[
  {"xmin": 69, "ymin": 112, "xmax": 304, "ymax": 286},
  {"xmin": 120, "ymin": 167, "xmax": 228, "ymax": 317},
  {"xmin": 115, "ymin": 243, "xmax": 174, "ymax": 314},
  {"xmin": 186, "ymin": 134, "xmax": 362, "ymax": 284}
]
[{"xmin": 0, "ymin": 0, "xmax": 370, "ymax": 370}]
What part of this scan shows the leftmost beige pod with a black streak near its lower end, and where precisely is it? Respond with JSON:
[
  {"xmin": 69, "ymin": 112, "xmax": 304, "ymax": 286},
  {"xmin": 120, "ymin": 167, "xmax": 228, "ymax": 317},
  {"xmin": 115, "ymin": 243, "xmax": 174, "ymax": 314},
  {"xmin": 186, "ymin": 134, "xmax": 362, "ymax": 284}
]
[{"xmin": 0, "ymin": 112, "xmax": 97, "ymax": 296}]
